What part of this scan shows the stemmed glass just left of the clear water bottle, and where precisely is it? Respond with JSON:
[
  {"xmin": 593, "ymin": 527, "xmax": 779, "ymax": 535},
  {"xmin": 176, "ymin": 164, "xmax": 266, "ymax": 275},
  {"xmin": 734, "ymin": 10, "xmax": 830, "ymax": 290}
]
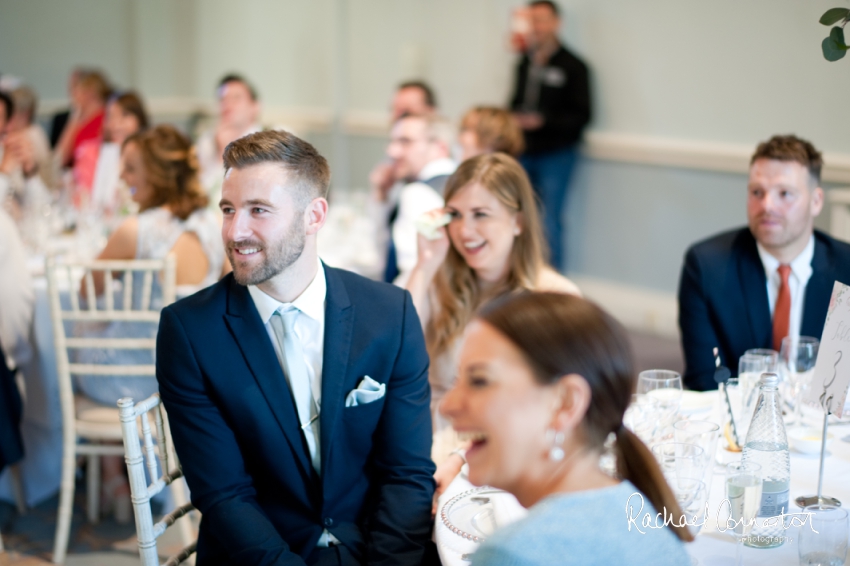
[{"xmin": 725, "ymin": 462, "xmax": 762, "ymax": 566}]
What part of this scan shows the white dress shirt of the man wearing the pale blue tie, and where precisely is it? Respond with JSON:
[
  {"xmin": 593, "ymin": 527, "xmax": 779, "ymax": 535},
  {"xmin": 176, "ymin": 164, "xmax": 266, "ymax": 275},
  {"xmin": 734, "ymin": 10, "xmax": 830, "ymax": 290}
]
[{"xmin": 248, "ymin": 262, "xmax": 339, "ymax": 547}]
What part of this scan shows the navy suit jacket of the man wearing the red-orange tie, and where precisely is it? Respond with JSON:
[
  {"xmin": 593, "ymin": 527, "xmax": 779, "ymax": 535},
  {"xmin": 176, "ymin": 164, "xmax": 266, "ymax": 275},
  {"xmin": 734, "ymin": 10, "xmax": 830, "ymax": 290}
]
[{"xmin": 679, "ymin": 228, "xmax": 850, "ymax": 391}]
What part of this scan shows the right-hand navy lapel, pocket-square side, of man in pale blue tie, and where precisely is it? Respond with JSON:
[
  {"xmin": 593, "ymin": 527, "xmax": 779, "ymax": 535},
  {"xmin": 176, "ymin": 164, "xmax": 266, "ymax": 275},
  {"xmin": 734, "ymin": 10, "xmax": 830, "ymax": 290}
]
[{"xmin": 320, "ymin": 266, "xmax": 354, "ymax": 491}]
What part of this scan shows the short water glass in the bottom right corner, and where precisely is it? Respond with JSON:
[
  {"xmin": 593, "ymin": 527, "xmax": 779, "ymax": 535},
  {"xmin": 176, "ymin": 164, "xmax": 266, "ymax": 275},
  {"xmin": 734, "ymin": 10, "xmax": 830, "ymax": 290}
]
[{"xmin": 799, "ymin": 504, "xmax": 847, "ymax": 566}]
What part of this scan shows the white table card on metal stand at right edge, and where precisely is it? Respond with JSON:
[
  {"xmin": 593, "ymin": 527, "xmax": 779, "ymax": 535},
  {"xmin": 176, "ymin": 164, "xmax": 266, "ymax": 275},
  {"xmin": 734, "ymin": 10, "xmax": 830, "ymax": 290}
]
[{"xmin": 806, "ymin": 281, "xmax": 850, "ymax": 417}]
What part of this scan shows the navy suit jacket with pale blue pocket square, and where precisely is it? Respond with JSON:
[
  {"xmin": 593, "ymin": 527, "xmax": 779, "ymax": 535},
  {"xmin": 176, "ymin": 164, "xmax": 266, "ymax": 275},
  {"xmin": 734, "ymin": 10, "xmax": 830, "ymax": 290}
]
[{"xmin": 157, "ymin": 267, "xmax": 434, "ymax": 565}]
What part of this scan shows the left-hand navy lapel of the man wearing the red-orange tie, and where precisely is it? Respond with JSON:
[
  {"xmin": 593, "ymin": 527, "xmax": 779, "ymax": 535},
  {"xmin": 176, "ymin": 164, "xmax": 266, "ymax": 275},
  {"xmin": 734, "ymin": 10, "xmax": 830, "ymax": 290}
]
[{"xmin": 738, "ymin": 230, "xmax": 773, "ymax": 348}]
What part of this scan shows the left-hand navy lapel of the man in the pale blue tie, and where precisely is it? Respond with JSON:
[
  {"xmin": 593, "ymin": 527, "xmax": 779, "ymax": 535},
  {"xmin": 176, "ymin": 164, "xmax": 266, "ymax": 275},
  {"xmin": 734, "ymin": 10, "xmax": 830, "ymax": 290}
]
[{"xmin": 224, "ymin": 276, "xmax": 314, "ymax": 477}]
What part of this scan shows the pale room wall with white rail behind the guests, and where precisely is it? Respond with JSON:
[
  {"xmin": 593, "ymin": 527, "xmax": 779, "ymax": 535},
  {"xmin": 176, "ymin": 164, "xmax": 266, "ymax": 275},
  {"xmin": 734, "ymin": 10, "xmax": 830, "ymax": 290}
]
[{"xmin": 0, "ymin": 0, "xmax": 850, "ymax": 328}]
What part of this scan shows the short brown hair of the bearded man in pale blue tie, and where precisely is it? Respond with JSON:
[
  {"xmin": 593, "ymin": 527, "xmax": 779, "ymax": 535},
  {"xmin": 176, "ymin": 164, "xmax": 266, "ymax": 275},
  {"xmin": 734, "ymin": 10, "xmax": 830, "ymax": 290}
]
[{"xmin": 224, "ymin": 130, "xmax": 331, "ymax": 205}]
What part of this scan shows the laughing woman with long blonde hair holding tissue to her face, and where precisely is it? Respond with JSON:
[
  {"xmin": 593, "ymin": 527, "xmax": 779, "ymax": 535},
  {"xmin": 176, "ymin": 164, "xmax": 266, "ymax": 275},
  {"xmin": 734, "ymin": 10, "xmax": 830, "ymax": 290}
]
[{"xmin": 407, "ymin": 153, "xmax": 579, "ymax": 474}]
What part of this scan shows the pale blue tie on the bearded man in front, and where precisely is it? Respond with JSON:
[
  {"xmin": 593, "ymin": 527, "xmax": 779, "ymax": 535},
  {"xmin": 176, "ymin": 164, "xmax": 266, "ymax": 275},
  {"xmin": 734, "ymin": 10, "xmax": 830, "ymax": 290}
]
[{"xmin": 271, "ymin": 305, "xmax": 321, "ymax": 474}]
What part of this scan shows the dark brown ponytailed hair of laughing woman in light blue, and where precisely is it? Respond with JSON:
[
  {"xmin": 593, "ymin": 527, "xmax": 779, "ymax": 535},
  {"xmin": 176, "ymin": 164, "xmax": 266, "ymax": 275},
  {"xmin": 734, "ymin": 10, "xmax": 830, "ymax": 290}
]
[{"xmin": 478, "ymin": 292, "xmax": 693, "ymax": 542}]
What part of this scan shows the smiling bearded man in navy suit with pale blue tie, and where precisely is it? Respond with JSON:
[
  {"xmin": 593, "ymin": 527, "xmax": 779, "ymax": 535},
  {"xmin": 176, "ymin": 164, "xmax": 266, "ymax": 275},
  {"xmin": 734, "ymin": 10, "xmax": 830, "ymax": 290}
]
[{"xmin": 157, "ymin": 131, "xmax": 434, "ymax": 565}]
